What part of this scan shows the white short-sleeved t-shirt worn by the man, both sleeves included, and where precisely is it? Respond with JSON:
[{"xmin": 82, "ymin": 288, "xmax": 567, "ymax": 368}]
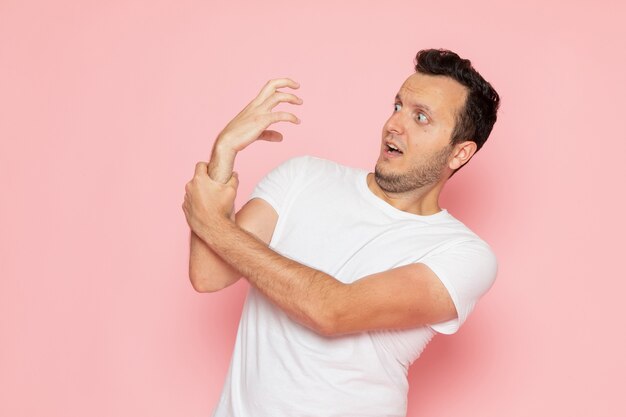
[{"xmin": 213, "ymin": 156, "xmax": 497, "ymax": 417}]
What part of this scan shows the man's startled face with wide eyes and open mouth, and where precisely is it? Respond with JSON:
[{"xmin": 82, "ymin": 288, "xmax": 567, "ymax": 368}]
[{"xmin": 375, "ymin": 72, "xmax": 467, "ymax": 193}]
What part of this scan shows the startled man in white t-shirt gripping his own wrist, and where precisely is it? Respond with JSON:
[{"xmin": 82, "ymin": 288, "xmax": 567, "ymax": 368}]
[{"xmin": 183, "ymin": 49, "xmax": 499, "ymax": 417}]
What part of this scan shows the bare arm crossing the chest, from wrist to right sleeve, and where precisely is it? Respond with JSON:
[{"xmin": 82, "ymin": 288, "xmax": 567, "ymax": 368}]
[{"xmin": 197, "ymin": 216, "xmax": 456, "ymax": 336}]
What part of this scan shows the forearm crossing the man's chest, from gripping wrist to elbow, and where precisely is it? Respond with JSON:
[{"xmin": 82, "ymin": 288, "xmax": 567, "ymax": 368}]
[{"xmin": 198, "ymin": 218, "xmax": 346, "ymax": 333}]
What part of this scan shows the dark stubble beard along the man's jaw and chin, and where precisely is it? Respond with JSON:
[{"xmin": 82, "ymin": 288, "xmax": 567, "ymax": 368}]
[{"xmin": 374, "ymin": 146, "xmax": 452, "ymax": 193}]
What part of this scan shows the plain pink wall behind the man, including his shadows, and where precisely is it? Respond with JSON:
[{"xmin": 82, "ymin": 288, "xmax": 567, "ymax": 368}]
[{"xmin": 0, "ymin": 0, "xmax": 626, "ymax": 417}]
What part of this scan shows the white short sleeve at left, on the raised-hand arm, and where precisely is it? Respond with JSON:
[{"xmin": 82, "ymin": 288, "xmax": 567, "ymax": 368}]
[{"xmin": 249, "ymin": 156, "xmax": 310, "ymax": 215}]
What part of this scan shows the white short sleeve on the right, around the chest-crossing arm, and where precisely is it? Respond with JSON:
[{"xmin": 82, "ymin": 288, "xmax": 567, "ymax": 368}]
[{"xmin": 420, "ymin": 240, "xmax": 498, "ymax": 334}]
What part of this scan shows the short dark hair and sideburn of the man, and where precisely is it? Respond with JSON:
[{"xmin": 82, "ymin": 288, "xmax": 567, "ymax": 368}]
[{"xmin": 415, "ymin": 49, "xmax": 500, "ymax": 172}]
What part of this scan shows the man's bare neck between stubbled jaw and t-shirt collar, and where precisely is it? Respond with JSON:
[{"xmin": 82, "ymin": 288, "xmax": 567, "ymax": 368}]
[{"xmin": 367, "ymin": 172, "xmax": 445, "ymax": 216}]
